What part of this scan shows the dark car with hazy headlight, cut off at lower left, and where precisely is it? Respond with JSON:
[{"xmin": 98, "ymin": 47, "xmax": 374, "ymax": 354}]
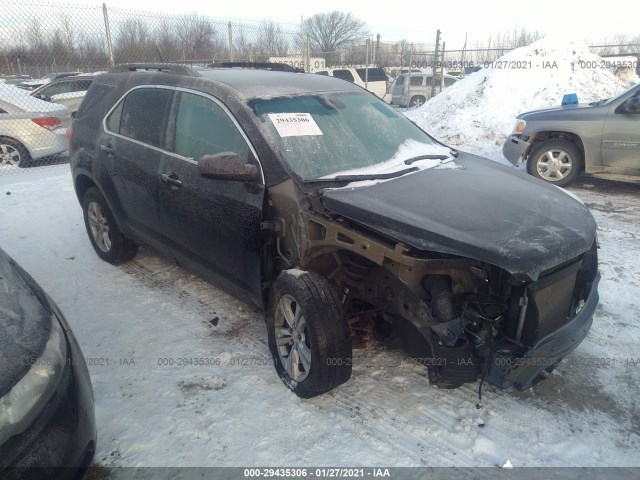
[{"xmin": 0, "ymin": 249, "xmax": 96, "ymax": 479}]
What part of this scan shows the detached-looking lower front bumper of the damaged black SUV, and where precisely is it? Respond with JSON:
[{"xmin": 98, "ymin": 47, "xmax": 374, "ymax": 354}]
[{"xmin": 486, "ymin": 274, "xmax": 600, "ymax": 390}]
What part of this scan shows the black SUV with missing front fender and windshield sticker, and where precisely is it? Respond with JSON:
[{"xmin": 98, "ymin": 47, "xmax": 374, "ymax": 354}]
[{"xmin": 70, "ymin": 65, "xmax": 599, "ymax": 397}]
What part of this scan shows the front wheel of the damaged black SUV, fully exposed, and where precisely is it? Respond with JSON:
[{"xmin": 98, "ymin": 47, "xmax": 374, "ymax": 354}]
[{"xmin": 266, "ymin": 270, "xmax": 351, "ymax": 398}]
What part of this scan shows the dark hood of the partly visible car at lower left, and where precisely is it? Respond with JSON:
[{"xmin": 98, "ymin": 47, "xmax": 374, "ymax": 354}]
[{"xmin": 0, "ymin": 249, "xmax": 51, "ymax": 397}]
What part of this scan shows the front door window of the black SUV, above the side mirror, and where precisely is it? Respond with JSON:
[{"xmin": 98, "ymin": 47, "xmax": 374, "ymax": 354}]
[{"xmin": 175, "ymin": 92, "xmax": 249, "ymax": 163}]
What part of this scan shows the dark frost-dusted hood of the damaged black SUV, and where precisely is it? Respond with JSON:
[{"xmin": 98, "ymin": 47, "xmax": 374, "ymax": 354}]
[{"xmin": 322, "ymin": 152, "xmax": 596, "ymax": 280}]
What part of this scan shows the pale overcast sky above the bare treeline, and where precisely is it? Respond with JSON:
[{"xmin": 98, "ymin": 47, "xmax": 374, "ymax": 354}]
[{"xmin": 92, "ymin": 0, "xmax": 640, "ymax": 49}]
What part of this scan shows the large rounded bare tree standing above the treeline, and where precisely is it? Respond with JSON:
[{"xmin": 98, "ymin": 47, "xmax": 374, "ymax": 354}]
[{"xmin": 304, "ymin": 10, "xmax": 369, "ymax": 62}]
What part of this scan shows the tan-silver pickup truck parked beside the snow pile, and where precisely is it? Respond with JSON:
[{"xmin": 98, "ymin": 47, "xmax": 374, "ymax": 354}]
[{"xmin": 502, "ymin": 84, "xmax": 640, "ymax": 187}]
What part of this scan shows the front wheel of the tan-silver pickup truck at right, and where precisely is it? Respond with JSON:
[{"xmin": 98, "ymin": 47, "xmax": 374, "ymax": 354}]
[{"xmin": 527, "ymin": 139, "xmax": 584, "ymax": 187}]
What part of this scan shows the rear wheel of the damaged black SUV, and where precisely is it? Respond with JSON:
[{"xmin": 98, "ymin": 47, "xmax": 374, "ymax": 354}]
[{"xmin": 82, "ymin": 187, "xmax": 138, "ymax": 265}]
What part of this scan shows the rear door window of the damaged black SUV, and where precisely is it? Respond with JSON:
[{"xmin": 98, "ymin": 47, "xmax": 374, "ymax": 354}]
[{"xmin": 115, "ymin": 88, "xmax": 173, "ymax": 148}]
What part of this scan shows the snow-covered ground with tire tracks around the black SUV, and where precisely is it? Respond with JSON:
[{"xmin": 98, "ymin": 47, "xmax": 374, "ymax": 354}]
[{"xmin": 0, "ymin": 165, "xmax": 640, "ymax": 470}]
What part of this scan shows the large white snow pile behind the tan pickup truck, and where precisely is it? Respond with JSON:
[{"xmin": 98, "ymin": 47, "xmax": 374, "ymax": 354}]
[{"xmin": 405, "ymin": 39, "xmax": 638, "ymax": 163}]
